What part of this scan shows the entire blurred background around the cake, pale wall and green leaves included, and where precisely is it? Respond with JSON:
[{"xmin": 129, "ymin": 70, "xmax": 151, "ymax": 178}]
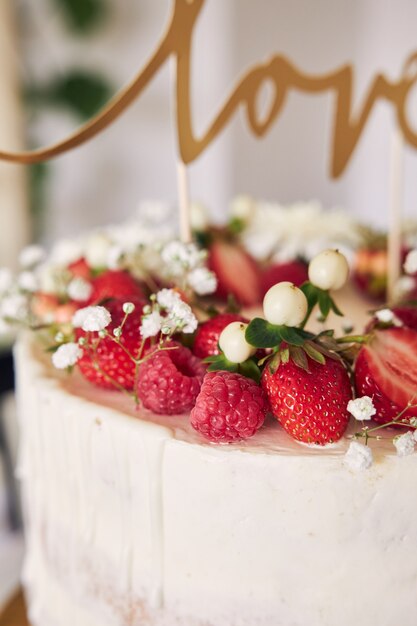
[{"xmin": 0, "ymin": 0, "xmax": 417, "ymax": 603}]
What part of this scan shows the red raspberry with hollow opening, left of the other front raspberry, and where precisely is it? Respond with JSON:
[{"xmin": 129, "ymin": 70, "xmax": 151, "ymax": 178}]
[{"xmin": 138, "ymin": 342, "xmax": 206, "ymax": 415}]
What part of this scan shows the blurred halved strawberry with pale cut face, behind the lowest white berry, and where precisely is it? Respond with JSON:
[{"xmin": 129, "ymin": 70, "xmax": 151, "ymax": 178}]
[{"xmin": 208, "ymin": 239, "xmax": 261, "ymax": 306}]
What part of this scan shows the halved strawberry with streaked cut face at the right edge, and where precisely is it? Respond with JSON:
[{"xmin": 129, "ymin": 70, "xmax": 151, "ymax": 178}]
[{"xmin": 355, "ymin": 328, "xmax": 417, "ymax": 423}]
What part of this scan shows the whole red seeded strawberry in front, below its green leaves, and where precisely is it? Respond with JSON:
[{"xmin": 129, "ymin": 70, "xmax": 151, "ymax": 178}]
[{"xmin": 261, "ymin": 357, "xmax": 352, "ymax": 445}]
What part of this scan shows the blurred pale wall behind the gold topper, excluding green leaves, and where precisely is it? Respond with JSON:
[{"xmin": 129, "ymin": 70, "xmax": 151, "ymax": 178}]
[{"xmin": 16, "ymin": 0, "xmax": 417, "ymax": 239}]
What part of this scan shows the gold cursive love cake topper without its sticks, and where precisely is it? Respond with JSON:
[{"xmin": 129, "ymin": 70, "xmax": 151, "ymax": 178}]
[{"xmin": 0, "ymin": 0, "xmax": 417, "ymax": 178}]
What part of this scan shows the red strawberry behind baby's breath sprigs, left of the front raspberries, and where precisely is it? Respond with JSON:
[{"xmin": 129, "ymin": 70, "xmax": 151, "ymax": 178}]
[{"xmin": 76, "ymin": 298, "xmax": 144, "ymax": 390}]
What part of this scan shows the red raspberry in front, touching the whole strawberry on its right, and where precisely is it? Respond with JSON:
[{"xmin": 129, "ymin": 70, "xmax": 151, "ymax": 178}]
[{"xmin": 190, "ymin": 370, "xmax": 268, "ymax": 443}]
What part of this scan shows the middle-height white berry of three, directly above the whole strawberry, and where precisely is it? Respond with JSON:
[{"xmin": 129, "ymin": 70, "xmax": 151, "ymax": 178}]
[{"xmin": 263, "ymin": 281, "xmax": 308, "ymax": 326}]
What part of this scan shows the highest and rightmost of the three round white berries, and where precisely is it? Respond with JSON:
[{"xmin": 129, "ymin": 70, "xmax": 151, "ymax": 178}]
[{"xmin": 308, "ymin": 250, "xmax": 349, "ymax": 291}]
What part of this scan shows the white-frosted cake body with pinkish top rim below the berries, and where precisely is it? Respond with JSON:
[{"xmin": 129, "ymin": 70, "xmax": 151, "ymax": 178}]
[{"xmin": 16, "ymin": 337, "xmax": 417, "ymax": 626}]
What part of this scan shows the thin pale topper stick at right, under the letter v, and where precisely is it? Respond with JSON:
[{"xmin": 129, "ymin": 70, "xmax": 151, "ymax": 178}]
[{"xmin": 387, "ymin": 128, "xmax": 404, "ymax": 302}]
